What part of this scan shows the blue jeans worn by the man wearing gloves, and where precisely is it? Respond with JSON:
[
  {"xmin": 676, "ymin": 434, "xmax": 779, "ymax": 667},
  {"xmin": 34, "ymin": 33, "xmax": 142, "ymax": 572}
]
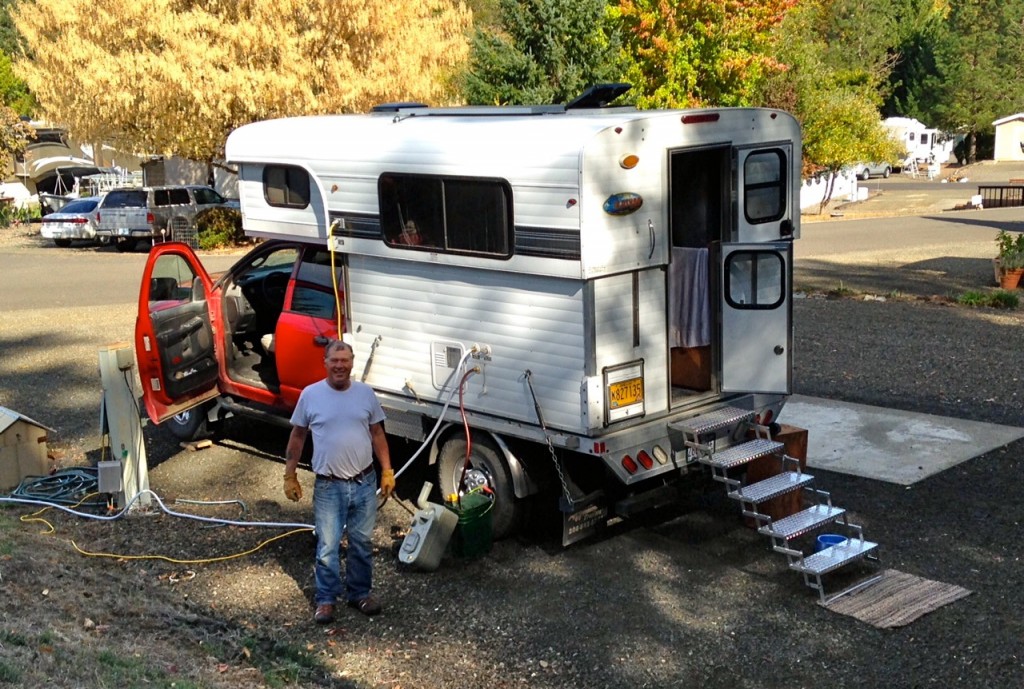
[{"xmin": 313, "ymin": 472, "xmax": 377, "ymax": 605}]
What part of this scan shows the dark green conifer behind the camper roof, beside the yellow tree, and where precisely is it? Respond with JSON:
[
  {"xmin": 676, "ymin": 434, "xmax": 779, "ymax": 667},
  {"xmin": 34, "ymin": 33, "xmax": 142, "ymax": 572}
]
[{"xmin": 461, "ymin": 0, "xmax": 621, "ymax": 104}]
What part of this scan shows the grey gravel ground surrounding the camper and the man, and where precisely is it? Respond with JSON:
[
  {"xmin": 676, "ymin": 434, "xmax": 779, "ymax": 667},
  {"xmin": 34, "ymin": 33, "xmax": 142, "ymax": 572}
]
[{"xmin": 0, "ymin": 222, "xmax": 1024, "ymax": 689}]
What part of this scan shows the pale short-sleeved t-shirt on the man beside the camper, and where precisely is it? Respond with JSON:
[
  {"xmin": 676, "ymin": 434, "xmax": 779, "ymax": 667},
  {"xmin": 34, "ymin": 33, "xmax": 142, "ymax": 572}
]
[{"xmin": 292, "ymin": 379, "xmax": 385, "ymax": 478}]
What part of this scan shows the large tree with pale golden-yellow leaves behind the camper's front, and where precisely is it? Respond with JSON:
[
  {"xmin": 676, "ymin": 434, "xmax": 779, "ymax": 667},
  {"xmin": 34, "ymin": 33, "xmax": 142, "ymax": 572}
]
[{"xmin": 12, "ymin": 0, "xmax": 471, "ymax": 161}]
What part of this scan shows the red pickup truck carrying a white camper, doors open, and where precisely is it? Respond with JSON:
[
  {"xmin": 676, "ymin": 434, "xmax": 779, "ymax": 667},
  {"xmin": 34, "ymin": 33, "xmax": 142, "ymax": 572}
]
[{"xmin": 136, "ymin": 87, "xmax": 801, "ymax": 544}]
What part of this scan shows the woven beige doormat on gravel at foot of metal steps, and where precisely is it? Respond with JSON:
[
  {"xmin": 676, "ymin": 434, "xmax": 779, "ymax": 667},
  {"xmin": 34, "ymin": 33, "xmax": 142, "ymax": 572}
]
[{"xmin": 819, "ymin": 569, "xmax": 971, "ymax": 630}]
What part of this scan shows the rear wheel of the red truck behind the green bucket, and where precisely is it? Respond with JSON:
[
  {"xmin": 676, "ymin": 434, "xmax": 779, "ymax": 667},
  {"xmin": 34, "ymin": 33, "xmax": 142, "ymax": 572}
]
[{"xmin": 437, "ymin": 435, "xmax": 522, "ymax": 540}]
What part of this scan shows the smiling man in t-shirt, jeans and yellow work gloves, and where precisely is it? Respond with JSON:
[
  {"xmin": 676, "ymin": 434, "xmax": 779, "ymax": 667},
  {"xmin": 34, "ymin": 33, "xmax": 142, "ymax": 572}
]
[{"xmin": 285, "ymin": 340, "xmax": 394, "ymax": 625}]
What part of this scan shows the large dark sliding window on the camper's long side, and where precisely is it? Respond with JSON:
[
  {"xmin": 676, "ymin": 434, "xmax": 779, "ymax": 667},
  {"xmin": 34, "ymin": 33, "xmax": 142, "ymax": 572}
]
[{"xmin": 378, "ymin": 173, "xmax": 513, "ymax": 258}]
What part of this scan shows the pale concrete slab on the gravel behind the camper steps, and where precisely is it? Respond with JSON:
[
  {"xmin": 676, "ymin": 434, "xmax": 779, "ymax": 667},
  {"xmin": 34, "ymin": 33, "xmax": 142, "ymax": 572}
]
[{"xmin": 779, "ymin": 395, "xmax": 1024, "ymax": 485}]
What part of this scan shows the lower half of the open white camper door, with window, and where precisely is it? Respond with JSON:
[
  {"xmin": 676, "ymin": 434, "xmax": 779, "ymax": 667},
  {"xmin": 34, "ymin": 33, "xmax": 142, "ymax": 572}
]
[{"xmin": 719, "ymin": 242, "xmax": 793, "ymax": 394}]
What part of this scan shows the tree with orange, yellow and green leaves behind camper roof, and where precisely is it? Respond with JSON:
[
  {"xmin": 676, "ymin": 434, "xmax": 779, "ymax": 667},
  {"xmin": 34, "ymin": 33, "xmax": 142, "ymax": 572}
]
[{"xmin": 610, "ymin": 0, "xmax": 797, "ymax": 107}]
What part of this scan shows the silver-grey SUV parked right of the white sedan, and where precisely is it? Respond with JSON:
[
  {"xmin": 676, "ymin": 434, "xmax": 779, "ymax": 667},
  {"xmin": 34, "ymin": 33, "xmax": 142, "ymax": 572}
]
[{"xmin": 95, "ymin": 184, "xmax": 239, "ymax": 251}]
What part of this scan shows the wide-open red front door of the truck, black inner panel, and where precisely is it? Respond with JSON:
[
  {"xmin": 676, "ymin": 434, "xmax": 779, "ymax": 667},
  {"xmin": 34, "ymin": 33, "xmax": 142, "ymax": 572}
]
[{"xmin": 135, "ymin": 243, "xmax": 219, "ymax": 424}]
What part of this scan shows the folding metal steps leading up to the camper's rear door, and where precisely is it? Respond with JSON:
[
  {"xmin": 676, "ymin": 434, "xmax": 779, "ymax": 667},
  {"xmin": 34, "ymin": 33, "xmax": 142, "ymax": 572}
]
[{"xmin": 670, "ymin": 406, "xmax": 882, "ymax": 604}]
